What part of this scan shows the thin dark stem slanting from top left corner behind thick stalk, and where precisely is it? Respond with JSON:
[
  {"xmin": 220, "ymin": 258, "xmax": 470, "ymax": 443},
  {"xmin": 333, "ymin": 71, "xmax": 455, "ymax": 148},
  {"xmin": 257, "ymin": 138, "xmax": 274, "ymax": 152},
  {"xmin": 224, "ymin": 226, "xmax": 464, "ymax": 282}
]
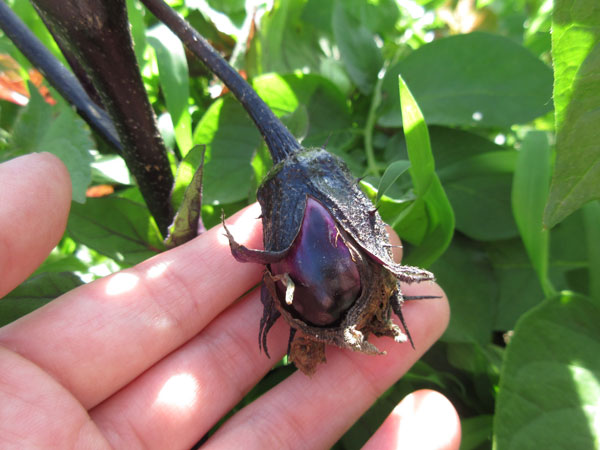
[{"xmin": 0, "ymin": 1, "xmax": 122, "ymax": 153}]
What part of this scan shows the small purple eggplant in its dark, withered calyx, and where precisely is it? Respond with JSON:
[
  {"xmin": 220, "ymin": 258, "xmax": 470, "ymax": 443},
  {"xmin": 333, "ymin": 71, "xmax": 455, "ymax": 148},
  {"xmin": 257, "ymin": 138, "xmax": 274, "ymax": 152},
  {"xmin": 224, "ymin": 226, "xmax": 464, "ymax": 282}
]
[{"xmin": 225, "ymin": 148, "xmax": 434, "ymax": 375}]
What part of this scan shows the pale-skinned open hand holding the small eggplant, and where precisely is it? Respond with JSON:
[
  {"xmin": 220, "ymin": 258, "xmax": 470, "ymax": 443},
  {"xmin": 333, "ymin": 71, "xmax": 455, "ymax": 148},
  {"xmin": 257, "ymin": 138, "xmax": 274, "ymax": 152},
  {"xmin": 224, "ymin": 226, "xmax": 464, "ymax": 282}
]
[{"xmin": 0, "ymin": 154, "xmax": 460, "ymax": 449}]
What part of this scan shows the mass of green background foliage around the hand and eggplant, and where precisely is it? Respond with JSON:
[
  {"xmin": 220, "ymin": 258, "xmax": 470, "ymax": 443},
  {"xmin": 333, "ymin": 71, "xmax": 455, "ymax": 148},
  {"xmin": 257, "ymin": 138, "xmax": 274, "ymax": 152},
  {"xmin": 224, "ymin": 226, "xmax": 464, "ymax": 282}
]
[{"xmin": 0, "ymin": 0, "xmax": 600, "ymax": 449}]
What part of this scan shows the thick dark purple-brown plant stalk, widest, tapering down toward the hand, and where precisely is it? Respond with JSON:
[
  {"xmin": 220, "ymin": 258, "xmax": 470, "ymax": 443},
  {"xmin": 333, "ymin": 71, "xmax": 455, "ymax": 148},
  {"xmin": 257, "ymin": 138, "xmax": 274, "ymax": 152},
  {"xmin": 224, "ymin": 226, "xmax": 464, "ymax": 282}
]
[{"xmin": 33, "ymin": 0, "xmax": 173, "ymax": 236}]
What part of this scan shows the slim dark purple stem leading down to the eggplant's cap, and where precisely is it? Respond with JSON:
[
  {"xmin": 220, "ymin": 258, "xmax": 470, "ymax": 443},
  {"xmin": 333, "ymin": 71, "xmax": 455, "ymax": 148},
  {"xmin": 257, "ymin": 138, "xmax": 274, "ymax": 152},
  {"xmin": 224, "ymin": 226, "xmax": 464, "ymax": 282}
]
[{"xmin": 141, "ymin": 0, "xmax": 301, "ymax": 164}]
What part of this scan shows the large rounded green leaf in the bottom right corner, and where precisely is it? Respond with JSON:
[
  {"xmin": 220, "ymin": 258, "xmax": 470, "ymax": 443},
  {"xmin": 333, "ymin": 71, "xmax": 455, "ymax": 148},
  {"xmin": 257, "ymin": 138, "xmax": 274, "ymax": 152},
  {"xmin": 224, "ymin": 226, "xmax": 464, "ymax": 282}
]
[{"xmin": 494, "ymin": 292, "xmax": 600, "ymax": 449}]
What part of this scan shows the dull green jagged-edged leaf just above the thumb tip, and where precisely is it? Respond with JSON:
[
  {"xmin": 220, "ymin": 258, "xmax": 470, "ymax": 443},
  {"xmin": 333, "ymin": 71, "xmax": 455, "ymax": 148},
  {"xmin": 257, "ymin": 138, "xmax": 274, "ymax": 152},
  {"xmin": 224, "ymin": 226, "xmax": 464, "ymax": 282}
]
[{"xmin": 9, "ymin": 84, "xmax": 94, "ymax": 203}]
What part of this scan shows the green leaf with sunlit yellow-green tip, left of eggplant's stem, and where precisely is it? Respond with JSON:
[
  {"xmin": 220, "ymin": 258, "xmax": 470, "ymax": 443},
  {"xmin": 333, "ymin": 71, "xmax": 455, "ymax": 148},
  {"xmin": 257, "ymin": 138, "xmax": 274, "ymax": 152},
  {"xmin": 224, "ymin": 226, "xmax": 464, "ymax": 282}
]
[{"xmin": 194, "ymin": 96, "xmax": 261, "ymax": 205}]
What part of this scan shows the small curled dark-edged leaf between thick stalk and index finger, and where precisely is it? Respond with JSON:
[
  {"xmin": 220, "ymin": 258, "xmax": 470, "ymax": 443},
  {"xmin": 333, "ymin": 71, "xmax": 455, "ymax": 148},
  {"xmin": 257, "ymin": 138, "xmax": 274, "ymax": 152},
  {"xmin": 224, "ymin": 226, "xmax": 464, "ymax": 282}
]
[{"xmin": 165, "ymin": 145, "xmax": 206, "ymax": 249}]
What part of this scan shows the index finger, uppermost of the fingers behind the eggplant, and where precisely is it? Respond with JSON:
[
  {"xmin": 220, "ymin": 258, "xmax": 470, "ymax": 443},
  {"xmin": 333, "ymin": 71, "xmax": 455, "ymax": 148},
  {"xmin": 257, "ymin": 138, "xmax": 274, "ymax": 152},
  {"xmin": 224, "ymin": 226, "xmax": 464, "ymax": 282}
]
[{"xmin": 0, "ymin": 205, "xmax": 262, "ymax": 409}]
